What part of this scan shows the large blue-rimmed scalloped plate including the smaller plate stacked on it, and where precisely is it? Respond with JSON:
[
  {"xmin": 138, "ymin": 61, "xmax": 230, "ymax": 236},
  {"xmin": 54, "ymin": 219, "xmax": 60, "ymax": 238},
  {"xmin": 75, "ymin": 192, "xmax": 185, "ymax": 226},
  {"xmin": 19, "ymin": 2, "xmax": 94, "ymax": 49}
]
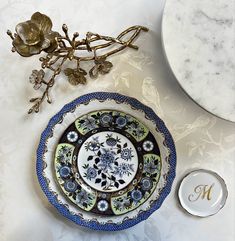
[{"xmin": 37, "ymin": 92, "xmax": 176, "ymax": 231}]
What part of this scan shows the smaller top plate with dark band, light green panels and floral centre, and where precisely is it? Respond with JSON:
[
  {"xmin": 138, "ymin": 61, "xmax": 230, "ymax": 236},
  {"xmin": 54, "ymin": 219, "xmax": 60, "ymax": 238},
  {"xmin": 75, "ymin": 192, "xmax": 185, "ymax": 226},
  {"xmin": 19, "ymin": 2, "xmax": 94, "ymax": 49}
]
[{"xmin": 54, "ymin": 109, "xmax": 162, "ymax": 216}]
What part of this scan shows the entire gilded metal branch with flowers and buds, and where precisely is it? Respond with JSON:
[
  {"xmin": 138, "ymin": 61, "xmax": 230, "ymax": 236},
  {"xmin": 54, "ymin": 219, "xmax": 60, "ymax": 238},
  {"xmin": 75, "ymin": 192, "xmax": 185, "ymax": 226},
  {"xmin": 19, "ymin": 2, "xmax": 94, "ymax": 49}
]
[{"xmin": 7, "ymin": 12, "xmax": 148, "ymax": 114}]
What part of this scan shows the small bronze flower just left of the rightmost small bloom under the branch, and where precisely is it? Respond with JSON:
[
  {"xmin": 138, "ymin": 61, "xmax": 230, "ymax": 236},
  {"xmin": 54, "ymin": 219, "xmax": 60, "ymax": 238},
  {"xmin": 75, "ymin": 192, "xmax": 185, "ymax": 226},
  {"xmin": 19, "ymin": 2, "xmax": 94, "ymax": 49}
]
[{"xmin": 64, "ymin": 68, "xmax": 87, "ymax": 85}]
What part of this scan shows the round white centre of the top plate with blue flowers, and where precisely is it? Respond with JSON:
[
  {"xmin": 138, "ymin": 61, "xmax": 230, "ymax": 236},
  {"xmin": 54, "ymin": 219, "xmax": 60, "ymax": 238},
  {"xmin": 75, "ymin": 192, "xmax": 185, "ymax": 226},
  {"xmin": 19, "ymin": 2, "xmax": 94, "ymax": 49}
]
[{"xmin": 77, "ymin": 131, "xmax": 138, "ymax": 192}]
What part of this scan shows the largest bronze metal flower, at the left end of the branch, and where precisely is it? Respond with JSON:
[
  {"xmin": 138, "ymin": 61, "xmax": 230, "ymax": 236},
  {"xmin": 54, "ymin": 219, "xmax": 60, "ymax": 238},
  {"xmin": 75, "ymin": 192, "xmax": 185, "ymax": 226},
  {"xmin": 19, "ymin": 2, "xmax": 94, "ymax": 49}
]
[{"xmin": 12, "ymin": 12, "xmax": 59, "ymax": 57}]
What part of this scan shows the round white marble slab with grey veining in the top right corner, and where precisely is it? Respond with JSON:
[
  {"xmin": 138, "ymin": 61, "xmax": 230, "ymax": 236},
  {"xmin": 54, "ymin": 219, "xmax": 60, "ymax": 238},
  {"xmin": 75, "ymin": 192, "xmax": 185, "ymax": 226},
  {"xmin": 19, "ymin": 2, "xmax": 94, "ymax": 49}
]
[{"xmin": 162, "ymin": 0, "xmax": 235, "ymax": 122}]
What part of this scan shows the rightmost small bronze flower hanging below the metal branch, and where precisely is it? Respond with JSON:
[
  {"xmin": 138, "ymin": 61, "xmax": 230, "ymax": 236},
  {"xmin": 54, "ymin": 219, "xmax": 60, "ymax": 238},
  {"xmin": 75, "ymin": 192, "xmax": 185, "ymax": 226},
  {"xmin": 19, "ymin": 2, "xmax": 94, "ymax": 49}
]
[{"xmin": 89, "ymin": 58, "xmax": 113, "ymax": 79}]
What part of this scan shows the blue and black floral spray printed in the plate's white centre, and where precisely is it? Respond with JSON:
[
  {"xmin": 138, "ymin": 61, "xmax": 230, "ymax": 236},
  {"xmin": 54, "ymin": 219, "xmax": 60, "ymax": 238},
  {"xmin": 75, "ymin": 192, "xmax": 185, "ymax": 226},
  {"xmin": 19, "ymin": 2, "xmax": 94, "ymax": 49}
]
[{"xmin": 82, "ymin": 132, "xmax": 136, "ymax": 190}]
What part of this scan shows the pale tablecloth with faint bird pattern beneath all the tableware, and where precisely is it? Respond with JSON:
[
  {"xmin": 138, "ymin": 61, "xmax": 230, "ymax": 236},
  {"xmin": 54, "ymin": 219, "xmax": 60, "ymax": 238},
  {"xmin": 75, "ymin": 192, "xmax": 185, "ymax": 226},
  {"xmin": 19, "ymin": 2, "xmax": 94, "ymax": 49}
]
[{"xmin": 0, "ymin": 0, "xmax": 235, "ymax": 241}]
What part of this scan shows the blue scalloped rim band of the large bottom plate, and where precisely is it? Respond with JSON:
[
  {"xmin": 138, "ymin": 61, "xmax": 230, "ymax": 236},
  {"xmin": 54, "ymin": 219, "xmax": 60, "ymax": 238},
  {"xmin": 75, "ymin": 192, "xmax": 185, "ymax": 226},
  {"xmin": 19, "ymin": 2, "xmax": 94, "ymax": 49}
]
[{"xmin": 36, "ymin": 92, "xmax": 176, "ymax": 231}]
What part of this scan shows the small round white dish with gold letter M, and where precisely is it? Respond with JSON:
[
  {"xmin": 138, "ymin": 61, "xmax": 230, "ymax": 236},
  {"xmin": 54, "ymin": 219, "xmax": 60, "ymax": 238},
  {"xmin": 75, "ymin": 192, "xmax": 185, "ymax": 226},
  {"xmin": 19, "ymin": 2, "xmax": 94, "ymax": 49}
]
[{"xmin": 178, "ymin": 169, "xmax": 228, "ymax": 217}]
